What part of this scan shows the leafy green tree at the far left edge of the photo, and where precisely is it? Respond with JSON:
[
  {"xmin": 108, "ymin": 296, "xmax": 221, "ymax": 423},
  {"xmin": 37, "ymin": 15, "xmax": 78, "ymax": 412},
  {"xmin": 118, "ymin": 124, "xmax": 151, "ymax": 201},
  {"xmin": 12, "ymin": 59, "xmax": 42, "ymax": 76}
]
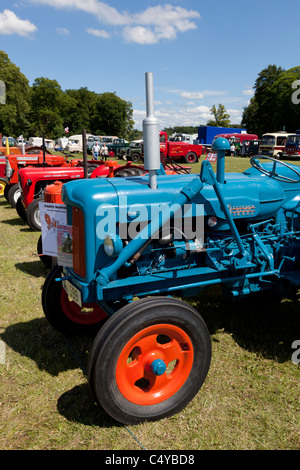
[{"xmin": 0, "ymin": 51, "xmax": 30, "ymax": 136}]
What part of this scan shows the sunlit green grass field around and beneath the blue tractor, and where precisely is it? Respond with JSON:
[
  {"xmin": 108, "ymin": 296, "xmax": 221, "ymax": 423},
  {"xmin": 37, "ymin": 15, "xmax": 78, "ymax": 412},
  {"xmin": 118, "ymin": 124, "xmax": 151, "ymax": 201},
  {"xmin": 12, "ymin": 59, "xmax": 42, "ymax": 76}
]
[{"xmin": 0, "ymin": 157, "xmax": 300, "ymax": 451}]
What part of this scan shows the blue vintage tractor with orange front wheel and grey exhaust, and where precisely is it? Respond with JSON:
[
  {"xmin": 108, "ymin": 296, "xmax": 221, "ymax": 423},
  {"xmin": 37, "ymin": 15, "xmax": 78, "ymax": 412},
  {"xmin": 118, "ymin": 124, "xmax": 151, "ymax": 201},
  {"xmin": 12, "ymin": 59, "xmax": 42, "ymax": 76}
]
[{"xmin": 42, "ymin": 74, "xmax": 300, "ymax": 424}]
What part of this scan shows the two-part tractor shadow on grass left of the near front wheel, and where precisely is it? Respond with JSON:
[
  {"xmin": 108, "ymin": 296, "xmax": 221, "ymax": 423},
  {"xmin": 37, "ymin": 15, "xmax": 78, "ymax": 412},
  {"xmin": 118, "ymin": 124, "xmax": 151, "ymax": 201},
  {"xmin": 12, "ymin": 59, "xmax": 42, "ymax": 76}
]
[{"xmin": 0, "ymin": 318, "xmax": 118, "ymax": 427}]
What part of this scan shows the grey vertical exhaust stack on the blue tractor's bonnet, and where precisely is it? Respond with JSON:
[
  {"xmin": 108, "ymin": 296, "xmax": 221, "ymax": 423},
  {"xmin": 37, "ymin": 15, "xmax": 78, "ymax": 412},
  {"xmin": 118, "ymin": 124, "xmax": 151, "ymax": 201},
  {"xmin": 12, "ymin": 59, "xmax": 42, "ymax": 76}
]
[{"xmin": 143, "ymin": 72, "xmax": 160, "ymax": 189}]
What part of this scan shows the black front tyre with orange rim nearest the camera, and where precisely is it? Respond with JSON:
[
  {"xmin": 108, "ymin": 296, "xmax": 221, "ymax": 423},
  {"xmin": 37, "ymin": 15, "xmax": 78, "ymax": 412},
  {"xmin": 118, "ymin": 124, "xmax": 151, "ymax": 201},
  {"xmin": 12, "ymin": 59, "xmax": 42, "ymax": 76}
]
[{"xmin": 88, "ymin": 297, "xmax": 211, "ymax": 425}]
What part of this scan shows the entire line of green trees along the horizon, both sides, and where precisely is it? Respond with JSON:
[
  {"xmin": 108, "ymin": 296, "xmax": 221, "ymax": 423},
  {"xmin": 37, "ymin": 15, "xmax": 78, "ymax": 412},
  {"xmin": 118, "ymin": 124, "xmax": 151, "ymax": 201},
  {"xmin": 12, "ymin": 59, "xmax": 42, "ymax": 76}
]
[{"xmin": 0, "ymin": 51, "xmax": 300, "ymax": 140}]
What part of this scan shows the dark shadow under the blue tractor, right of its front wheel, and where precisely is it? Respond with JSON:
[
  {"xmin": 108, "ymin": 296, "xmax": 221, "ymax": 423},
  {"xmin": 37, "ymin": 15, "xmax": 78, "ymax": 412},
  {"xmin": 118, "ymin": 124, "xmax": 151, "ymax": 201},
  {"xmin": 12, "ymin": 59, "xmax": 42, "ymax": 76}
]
[{"xmin": 191, "ymin": 288, "xmax": 300, "ymax": 363}]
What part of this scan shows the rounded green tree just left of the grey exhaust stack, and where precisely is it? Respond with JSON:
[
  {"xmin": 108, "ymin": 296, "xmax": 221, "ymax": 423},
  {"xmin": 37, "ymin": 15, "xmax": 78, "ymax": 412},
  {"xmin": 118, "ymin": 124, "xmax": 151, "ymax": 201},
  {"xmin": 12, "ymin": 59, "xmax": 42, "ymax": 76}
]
[{"xmin": 91, "ymin": 92, "xmax": 134, "ymax": 139}]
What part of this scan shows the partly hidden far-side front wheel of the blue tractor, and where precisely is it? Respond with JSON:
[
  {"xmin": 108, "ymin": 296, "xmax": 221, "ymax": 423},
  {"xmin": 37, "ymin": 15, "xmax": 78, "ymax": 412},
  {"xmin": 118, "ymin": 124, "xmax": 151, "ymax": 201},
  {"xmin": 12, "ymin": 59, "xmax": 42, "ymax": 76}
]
[{"xmin": 42, "ymin": 265, "xmax": 107, "ymax": 335}]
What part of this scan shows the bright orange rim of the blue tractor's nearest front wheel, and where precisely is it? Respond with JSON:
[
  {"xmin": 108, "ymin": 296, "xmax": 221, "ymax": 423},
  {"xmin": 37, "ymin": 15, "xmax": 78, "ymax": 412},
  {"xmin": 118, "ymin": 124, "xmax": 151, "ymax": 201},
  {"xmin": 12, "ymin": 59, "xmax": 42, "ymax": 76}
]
[{"xmin": 116, "ymin": 324, "xmax": 194, "ymax": 405}]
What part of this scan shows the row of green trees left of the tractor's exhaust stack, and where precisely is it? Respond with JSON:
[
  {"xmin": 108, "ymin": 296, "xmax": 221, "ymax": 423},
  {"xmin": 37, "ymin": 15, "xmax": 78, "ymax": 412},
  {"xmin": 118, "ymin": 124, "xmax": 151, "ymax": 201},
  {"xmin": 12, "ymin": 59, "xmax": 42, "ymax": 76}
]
[{"xmin": 0, "ymin": 51, "xmax": 134, "ymax": 139}]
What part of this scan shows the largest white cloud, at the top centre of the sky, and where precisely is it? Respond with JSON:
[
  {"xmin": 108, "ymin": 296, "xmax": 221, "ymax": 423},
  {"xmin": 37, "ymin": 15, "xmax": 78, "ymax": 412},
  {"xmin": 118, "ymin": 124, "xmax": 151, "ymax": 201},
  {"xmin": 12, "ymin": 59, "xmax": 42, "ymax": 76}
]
[{"xmin": 31, "ymin": 0, "xmax": 200, "ymax": 44}]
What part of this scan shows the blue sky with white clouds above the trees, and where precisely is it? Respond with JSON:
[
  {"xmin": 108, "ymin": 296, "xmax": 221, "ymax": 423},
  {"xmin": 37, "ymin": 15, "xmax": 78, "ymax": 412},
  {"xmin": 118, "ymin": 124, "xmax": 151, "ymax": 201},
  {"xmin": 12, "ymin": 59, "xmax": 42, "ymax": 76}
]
[{"xmin": 0, "ymin": 0, "xmax": 300, "ymax": 129}]
